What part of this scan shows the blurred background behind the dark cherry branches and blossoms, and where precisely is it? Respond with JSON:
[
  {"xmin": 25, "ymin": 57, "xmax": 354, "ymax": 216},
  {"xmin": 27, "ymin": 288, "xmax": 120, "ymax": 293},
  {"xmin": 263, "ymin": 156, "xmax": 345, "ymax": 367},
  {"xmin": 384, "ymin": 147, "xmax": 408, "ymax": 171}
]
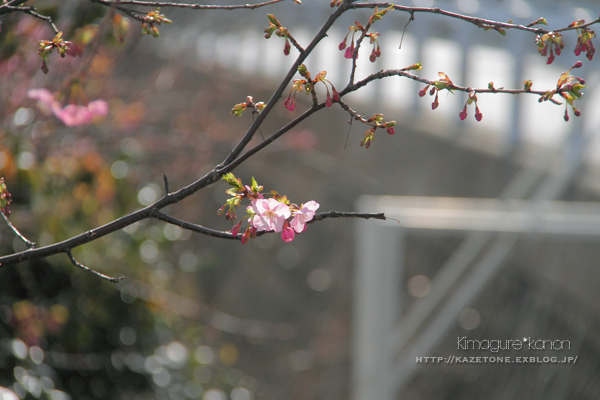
[{"xmin": 0, "ymin": 0, "xmax": 600, "ymax": 400}]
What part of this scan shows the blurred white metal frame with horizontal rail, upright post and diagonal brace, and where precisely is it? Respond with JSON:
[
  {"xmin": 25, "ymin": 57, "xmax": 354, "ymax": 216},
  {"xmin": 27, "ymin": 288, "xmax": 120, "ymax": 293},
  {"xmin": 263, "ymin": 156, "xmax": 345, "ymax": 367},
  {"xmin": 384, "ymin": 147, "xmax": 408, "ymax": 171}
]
[{"xmin": 351, "ymin": 195, "xmax": 600, "ymax": 400}]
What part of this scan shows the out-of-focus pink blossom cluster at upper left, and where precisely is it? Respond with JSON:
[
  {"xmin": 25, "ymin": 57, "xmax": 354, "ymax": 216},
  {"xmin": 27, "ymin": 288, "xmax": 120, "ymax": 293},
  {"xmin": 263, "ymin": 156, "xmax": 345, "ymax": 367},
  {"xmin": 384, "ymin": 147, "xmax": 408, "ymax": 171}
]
[{"xmin": 27, "ymin": 89, "xmax": 108, "ymax": 126}]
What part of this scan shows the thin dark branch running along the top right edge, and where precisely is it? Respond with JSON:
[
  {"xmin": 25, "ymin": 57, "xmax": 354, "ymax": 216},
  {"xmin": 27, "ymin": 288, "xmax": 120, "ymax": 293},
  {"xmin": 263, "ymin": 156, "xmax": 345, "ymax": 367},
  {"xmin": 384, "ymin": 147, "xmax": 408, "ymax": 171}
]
[{"xmin": 348, "ymin": 3, "xmax": 600, "ymax": 35}]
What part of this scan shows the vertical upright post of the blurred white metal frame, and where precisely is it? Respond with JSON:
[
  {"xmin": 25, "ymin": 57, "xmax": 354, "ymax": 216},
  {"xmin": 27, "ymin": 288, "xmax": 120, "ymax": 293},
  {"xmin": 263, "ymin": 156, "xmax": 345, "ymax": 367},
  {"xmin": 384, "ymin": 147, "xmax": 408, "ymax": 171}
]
[{"xmin": 351, "ymin": 197, "xmax": 404, "ymax": 400}]
